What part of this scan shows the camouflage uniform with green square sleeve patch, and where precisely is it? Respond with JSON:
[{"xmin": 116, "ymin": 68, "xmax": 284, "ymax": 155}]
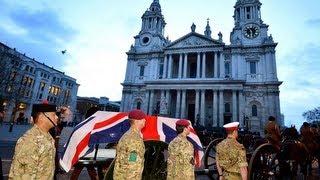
[{"xmin": 113, "ymin": 128, "xmax": 145, "ymax": 180}]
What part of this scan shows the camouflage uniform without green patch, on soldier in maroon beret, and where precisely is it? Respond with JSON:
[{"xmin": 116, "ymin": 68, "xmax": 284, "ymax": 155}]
[{"xmin": 167, "ymin": 135, "xmax": 195, "ymax": 180}]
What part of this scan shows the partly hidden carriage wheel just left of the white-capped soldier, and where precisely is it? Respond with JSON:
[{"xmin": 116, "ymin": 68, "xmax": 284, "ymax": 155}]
[{"xmin": 204, "ymin": 138, "xmax": 223, "ymax": 179}]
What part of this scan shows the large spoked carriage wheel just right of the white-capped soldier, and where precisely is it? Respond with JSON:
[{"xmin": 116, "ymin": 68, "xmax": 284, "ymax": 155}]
[{"xmin": 249, "ymin": 143, "xmax": 280, "ymax": 180}]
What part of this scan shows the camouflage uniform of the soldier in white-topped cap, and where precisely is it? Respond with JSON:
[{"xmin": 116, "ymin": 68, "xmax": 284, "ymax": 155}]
[{"xmin": 216, "ymin": 138, "xmax": 248, "ymax": 180}]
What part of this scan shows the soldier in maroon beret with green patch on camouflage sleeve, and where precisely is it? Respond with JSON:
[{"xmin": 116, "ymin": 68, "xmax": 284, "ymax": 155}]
[{"xmin": 113, "ymin": 110, "xmax": 146, "ymax": 180}]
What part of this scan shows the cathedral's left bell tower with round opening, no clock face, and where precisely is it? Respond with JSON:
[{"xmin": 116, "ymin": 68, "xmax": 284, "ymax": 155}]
[{"xmin": 131, "ymin": 0, "xmax": 167, "ymax": 52}]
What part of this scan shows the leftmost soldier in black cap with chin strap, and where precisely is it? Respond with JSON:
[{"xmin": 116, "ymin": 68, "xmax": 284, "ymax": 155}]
[{"xmin": 9, "ymin": 104, "xmax": 58, "ymax": 180}]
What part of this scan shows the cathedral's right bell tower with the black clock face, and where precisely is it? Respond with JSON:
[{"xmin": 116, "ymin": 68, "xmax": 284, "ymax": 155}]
[{"xmin": 230, "ymin": 0, "xmax": 269, "ymax": 45}]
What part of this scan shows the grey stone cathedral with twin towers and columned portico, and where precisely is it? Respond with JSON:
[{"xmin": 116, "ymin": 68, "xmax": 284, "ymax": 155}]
[{"xmin": 121, "ymin": 0, "xmax": 282, "ymax": 131}]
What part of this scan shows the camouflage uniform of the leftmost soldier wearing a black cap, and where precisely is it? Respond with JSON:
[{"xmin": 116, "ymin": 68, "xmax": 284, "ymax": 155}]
[{"xmin": 9, "ymin": 125, "xmax": 56, "ymax": 180}]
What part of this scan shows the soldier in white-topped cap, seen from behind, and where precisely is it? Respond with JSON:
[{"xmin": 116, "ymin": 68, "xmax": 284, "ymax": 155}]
[{"xmin": 216, "ymin": 122, "xmax": 248, "ymax": 180}]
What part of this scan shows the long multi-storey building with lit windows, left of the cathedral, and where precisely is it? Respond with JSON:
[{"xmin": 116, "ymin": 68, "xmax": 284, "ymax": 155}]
[{"xmin": 0, "ymin": 43, "xmax": 79, "ymax": 121}]
